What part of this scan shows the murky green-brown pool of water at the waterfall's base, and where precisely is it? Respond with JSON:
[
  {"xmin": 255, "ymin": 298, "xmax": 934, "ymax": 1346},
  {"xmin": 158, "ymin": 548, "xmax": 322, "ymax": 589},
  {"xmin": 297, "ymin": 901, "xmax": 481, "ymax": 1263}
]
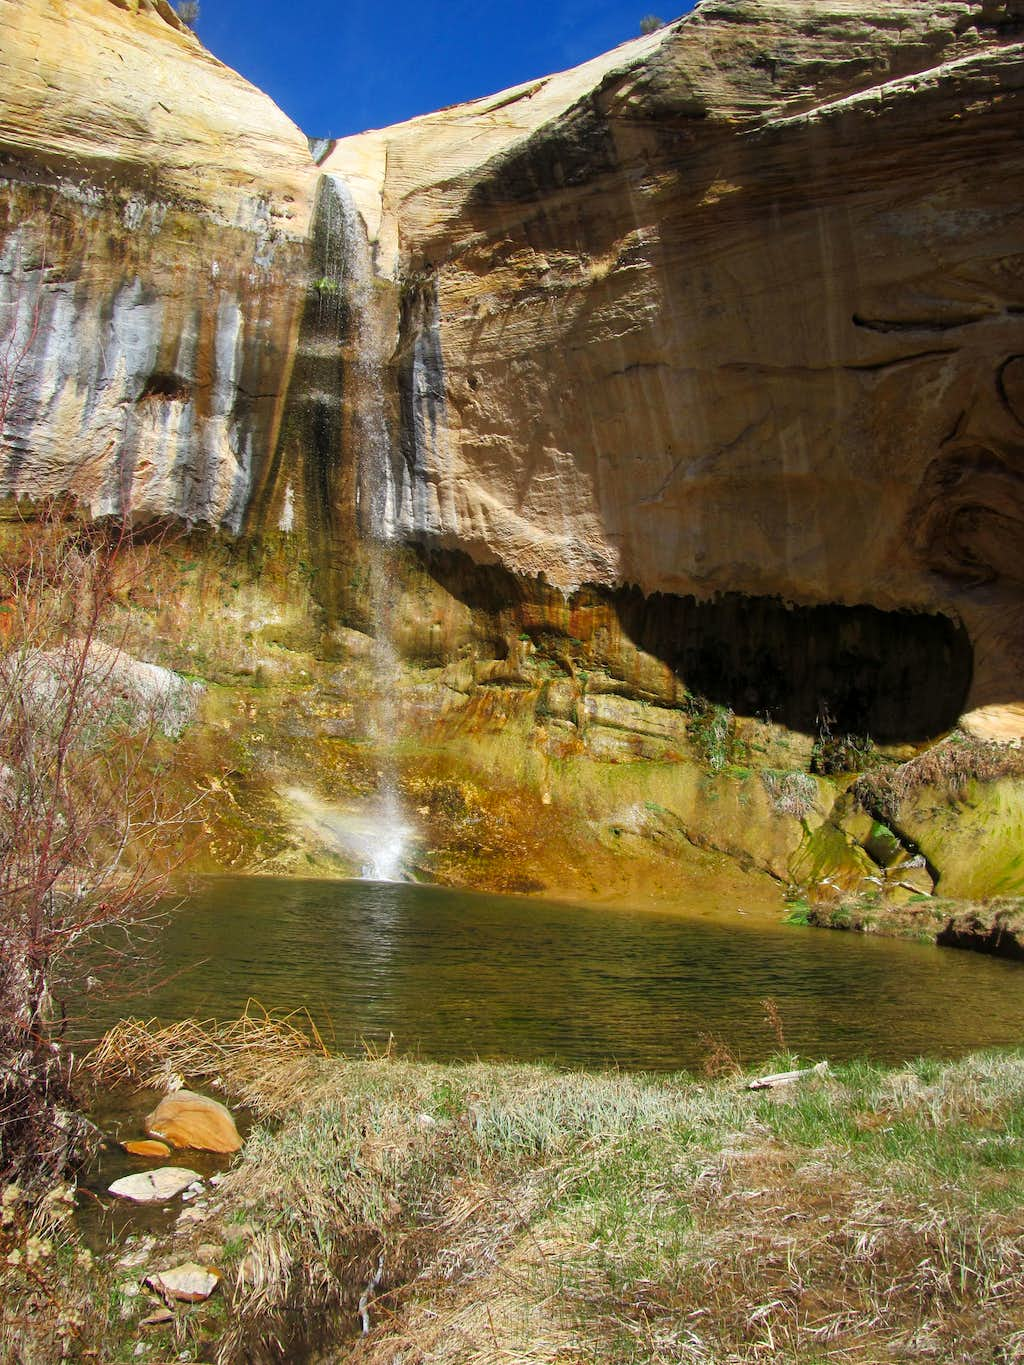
[{"xmin": 80, "ymin": 878, "xmax": 1024, "ymax": 1070}]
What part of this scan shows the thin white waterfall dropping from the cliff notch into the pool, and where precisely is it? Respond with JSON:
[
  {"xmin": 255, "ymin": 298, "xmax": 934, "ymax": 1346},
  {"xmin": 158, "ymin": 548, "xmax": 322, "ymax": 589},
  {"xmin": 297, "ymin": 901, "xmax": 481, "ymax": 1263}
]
[{"xmin": 318, "ymin": 175, "xmax": 412, "ymax": 882}]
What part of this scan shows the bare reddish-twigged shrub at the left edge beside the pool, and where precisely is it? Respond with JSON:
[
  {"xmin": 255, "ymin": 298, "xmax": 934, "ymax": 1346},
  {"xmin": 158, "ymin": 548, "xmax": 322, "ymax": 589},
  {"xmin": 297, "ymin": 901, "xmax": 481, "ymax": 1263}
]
[{"xmin": 0, "ymin": 509, "xmax": 199, "ymax": 1179}]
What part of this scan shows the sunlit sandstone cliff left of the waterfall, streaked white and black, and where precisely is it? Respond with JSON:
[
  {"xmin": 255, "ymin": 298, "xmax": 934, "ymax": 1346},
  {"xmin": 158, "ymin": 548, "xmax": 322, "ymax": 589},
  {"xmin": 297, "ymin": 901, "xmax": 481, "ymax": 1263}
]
[{"xmin": 0, "ymin": 0, "xmax": 313, "ymax": 531}]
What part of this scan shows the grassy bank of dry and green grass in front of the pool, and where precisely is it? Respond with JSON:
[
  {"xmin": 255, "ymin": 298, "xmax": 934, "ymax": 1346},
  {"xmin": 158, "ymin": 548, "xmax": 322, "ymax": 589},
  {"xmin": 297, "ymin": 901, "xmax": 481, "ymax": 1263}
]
[{"xmin": 0, "ymin": 1026, "xmax": 1024, "ymax": 1365}]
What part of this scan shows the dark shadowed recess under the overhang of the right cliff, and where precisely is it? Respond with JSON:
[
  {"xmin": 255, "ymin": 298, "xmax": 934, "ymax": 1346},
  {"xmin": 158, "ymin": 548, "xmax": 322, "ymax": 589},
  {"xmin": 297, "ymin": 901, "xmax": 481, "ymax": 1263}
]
[{"xmin": 421, "ymin": 549, "xmax": 972, "ymax": 744}]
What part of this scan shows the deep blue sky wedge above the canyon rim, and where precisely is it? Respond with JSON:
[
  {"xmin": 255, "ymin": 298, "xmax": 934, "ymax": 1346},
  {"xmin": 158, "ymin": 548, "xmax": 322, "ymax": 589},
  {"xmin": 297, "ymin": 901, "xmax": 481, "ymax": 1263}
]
[{"xmin": 197, "ymin": 0, "xmax": 691, "ymax": 137}]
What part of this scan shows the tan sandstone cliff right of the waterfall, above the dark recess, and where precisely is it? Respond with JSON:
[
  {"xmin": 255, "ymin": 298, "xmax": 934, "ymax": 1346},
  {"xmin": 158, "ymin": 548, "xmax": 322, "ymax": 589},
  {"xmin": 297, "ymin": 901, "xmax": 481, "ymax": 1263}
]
[{"xmin": 325, "ymin": 0, "xmax": 1024, "ymax": 737}]
